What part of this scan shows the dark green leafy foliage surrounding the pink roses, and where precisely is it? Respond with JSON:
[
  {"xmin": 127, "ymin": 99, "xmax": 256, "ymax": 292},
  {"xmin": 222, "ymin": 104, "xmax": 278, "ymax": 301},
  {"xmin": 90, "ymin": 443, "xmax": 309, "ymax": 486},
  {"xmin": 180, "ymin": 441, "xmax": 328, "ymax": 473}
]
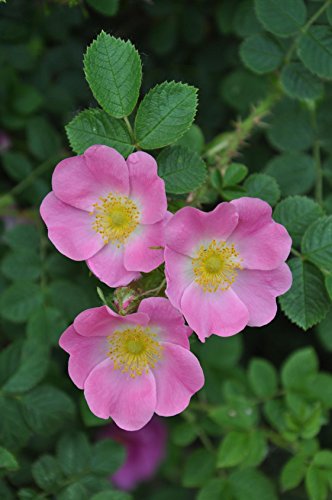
[{"xmin": 0, "ymin": 0, "xmax": 332, "ymax": 500}]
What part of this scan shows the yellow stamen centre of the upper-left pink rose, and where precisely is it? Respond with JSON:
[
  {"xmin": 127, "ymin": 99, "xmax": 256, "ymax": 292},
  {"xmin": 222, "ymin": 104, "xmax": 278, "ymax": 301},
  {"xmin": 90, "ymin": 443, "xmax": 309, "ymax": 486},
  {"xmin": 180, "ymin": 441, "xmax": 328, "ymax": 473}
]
[{"xmin": 91, "ymin": 193, "xmax": 140, "ymax": 246}]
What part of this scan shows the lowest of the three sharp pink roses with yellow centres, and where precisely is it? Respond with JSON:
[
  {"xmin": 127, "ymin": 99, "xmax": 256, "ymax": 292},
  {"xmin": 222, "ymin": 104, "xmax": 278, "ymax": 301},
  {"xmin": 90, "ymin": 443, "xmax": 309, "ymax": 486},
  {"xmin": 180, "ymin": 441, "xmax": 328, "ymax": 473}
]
[{"xmin": 59, "ymin": 297, "xmax": 204, "ymax": 431}]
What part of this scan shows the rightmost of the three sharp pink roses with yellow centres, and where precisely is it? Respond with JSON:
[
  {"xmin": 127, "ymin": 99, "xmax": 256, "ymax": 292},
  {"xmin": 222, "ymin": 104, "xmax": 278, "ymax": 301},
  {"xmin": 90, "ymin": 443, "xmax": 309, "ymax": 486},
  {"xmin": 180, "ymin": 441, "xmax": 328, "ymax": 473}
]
[{"xmin": 165, "ymin": 198, "xmax": 292, "ymax": 342}]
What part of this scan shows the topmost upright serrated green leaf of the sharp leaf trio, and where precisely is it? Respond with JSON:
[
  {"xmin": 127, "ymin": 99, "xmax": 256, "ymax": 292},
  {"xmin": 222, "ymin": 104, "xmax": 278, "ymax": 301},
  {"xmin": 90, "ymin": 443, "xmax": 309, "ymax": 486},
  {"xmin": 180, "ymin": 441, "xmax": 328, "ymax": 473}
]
[{"xmin": 84, "ymin": 31, "xmax": 142, "ymax": 118}]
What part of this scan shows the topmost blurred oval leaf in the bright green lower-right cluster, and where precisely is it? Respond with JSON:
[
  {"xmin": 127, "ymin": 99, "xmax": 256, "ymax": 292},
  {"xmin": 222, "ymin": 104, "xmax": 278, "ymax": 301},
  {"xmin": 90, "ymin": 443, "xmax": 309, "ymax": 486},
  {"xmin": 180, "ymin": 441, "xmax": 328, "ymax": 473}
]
[{"xmin": 281, "ymin": 347, "xmax": 318, "ymax": 391}]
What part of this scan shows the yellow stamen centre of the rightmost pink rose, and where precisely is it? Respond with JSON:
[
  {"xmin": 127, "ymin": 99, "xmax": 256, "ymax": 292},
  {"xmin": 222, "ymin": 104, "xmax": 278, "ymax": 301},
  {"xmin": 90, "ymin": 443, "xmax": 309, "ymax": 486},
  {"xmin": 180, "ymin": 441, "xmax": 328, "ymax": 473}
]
[{"xmin": 192, "ymin": 240, "xmax": 242, "ymax": 292}]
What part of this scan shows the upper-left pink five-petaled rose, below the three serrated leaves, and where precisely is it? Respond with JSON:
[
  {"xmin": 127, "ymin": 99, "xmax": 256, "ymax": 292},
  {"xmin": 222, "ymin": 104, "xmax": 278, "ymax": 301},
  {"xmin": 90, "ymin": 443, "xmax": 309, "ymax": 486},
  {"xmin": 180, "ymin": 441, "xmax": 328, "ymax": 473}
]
[{"xmin": 40, "ymin": 145, "xmax": 168, "ymax": 287}]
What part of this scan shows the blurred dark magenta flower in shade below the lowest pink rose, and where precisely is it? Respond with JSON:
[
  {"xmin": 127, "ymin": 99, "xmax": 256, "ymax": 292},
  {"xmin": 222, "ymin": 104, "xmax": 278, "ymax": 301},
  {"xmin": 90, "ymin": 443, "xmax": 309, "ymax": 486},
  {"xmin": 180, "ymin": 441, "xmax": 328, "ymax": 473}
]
[{"xmin": 98, "ymin": 417, "xmax": 167, "ymax": 490}]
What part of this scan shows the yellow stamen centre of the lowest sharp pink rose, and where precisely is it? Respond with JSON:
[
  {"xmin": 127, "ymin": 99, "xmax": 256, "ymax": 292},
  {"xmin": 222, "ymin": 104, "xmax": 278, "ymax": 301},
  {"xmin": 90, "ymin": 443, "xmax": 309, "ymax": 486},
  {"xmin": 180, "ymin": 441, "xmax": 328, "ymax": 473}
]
[{"xmin": 108, "ymin": 326, "xmax": 162, "ymax": 378}]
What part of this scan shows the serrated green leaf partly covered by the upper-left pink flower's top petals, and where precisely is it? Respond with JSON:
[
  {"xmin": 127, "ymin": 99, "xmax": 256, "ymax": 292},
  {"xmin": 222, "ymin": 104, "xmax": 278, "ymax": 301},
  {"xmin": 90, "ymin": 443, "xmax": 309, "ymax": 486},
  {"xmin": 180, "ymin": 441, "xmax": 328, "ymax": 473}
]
[{"xmin": 65, "ymin": 109, "xmax": 134, "ymax": 156}]
